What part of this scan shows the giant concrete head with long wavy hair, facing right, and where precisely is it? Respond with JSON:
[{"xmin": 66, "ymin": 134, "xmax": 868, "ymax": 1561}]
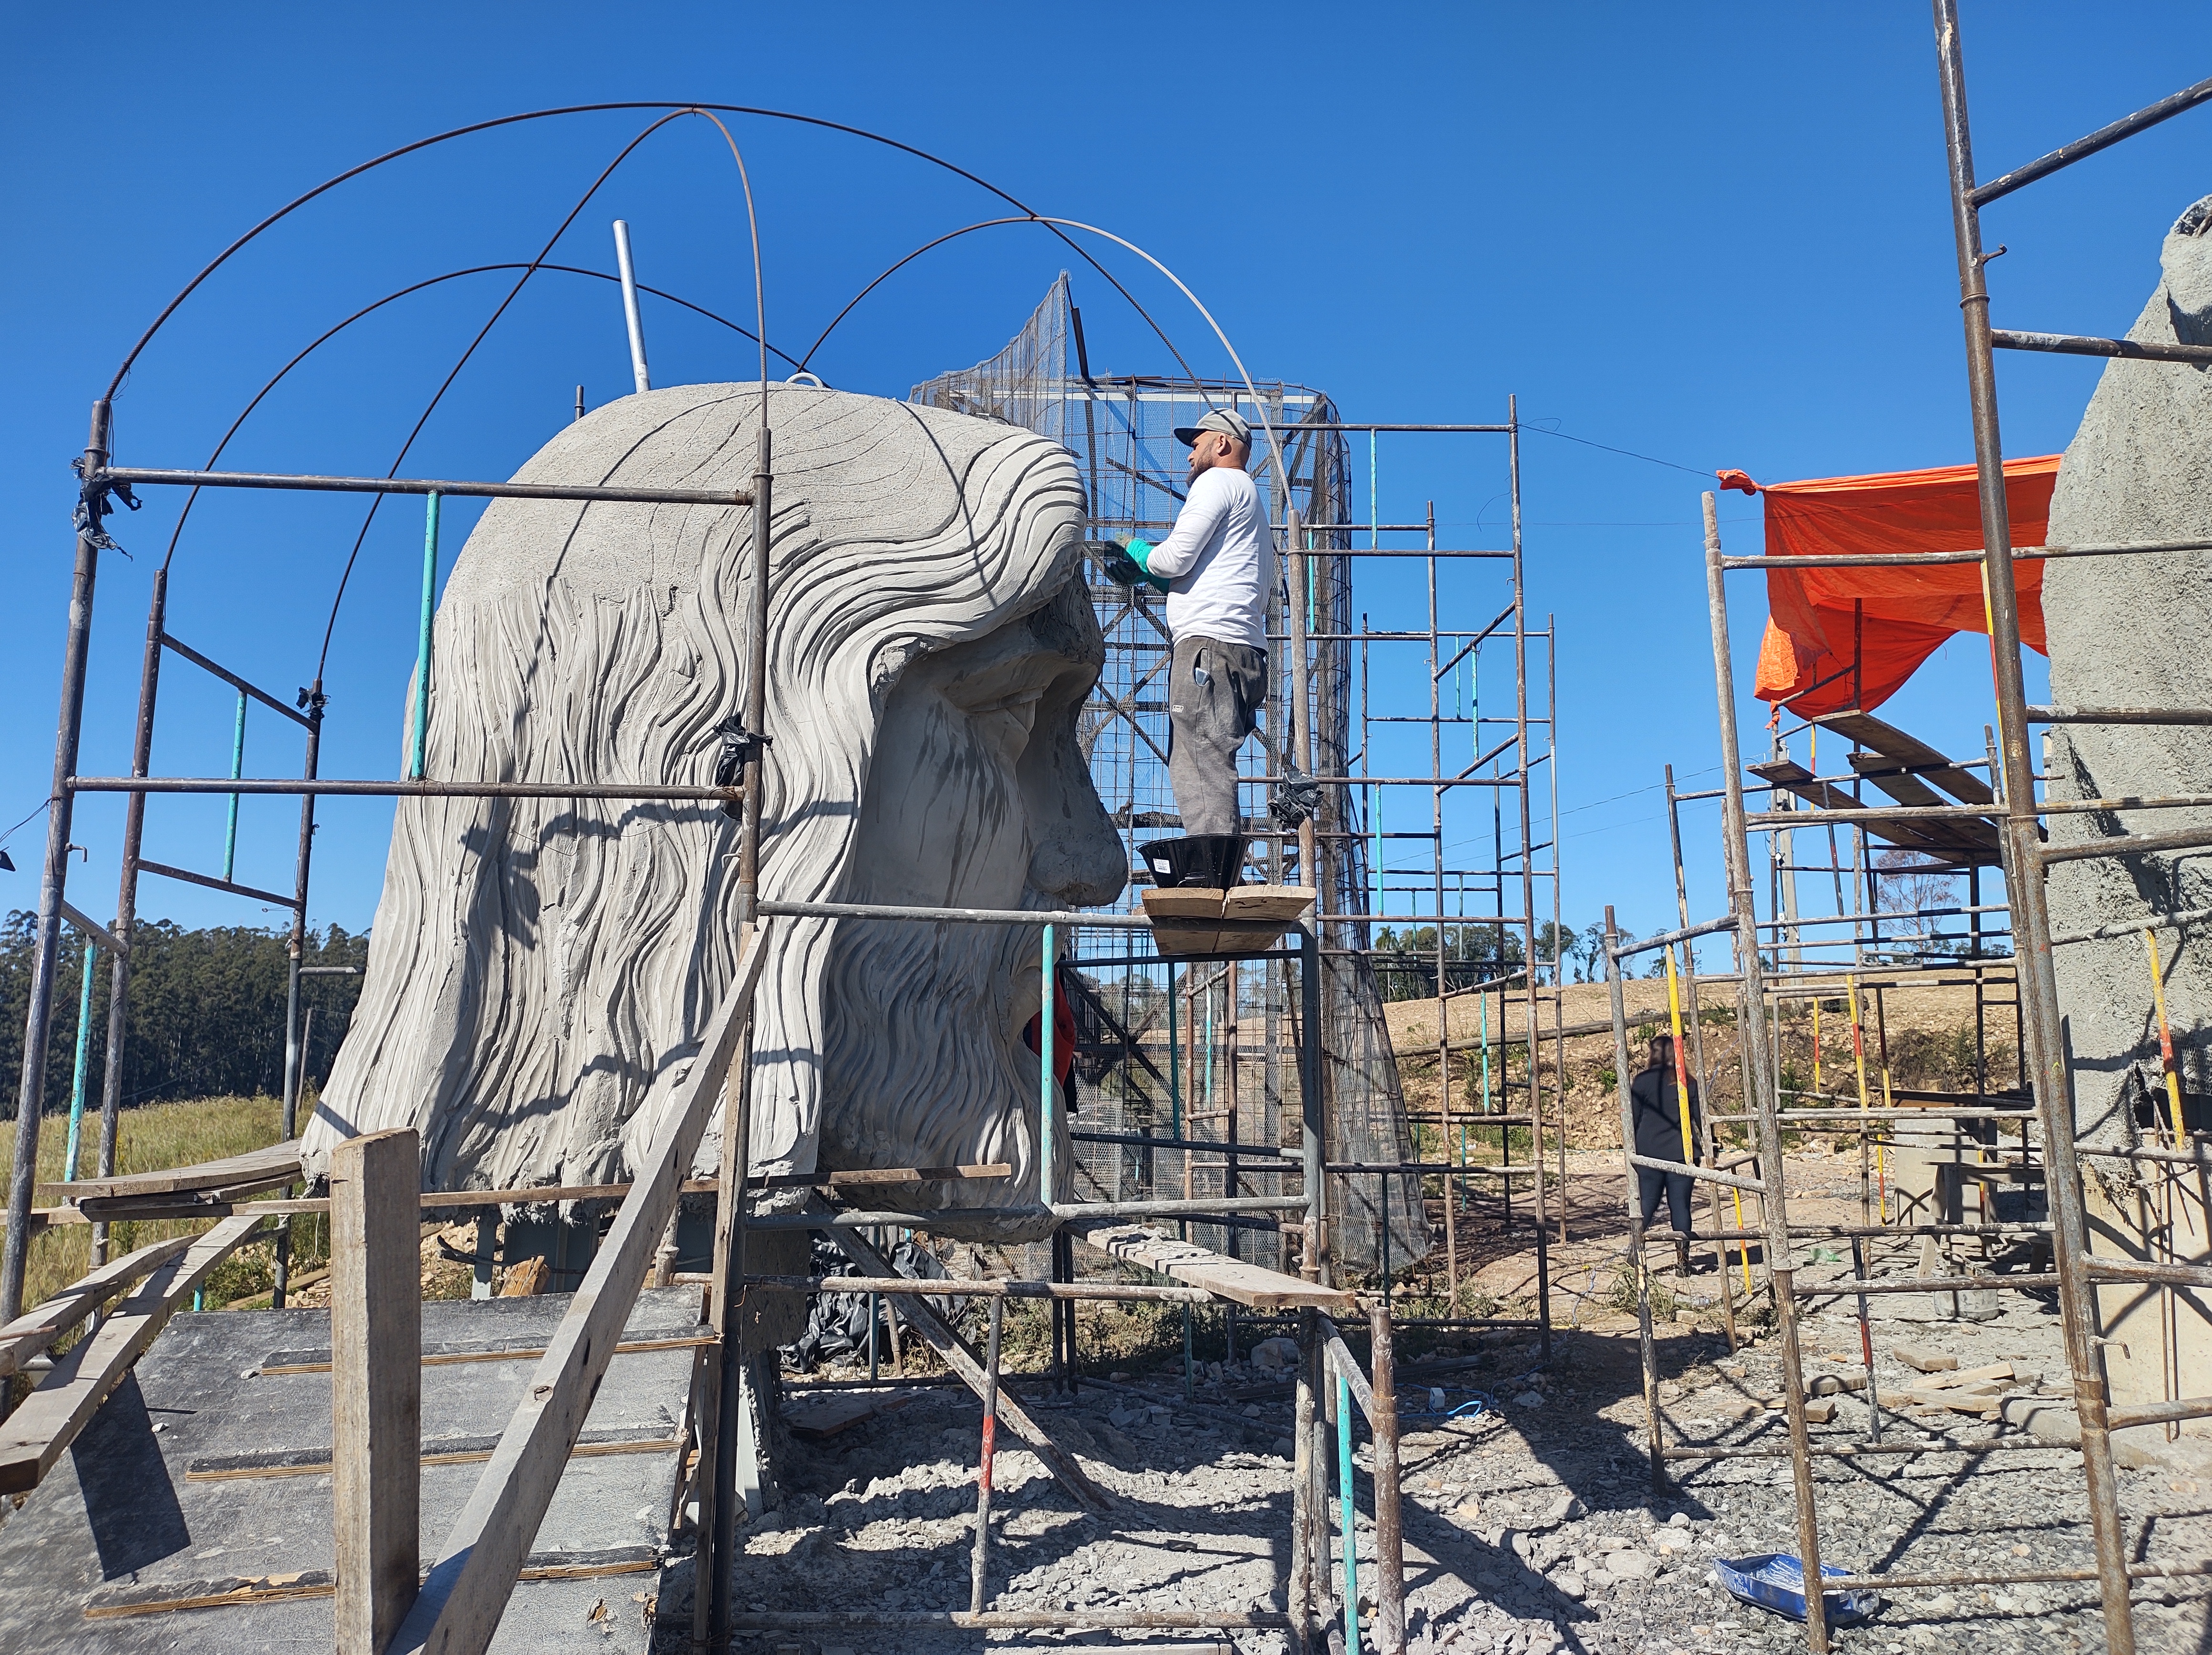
[{"xmin": 307, "ymin": 385, "xmax": 1126, "ymax": 1235}]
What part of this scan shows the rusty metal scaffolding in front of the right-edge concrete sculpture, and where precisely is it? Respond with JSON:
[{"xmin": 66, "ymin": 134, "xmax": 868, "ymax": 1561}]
[{"xmin": 1606, "ymin": 0, "xmax": 2212, "ymax": 1655}]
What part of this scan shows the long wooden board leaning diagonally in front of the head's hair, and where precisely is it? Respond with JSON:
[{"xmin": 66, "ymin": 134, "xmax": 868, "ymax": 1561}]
[{"xmin": 387, "ymin": 920, "xmax": 774, "ymax": 1655}]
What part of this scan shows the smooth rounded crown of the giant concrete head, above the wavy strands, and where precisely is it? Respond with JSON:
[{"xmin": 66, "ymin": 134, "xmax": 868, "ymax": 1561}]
[{"xmin": 447, "ymin": 385, "xmax": 1048, "ymax": 602}]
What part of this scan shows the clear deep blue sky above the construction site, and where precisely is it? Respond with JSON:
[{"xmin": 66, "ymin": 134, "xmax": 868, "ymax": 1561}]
[{"xmin": 0, "ymin": 0, "xmax": 2212, "ymax": 956}]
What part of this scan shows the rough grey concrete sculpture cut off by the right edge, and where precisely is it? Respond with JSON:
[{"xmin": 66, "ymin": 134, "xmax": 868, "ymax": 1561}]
[{"xmin": 2042, "ymin": 197, "xmax": 2212, "ymax": 1430}]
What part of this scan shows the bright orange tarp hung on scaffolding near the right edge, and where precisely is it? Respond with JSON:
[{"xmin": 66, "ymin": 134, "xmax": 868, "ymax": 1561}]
[{"xmin": 1721, "ymin": 454, "xmax": 2059, "ymax": 717}]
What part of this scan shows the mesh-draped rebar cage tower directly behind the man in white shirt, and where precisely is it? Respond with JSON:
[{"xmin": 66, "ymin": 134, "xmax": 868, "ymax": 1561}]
[{"xmin": 911, "ymin": 272, "xmax": 1429, "ymax": 1270}]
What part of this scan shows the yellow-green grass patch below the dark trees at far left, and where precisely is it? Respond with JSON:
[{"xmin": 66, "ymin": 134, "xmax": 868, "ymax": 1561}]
[{"xmin": 0, "ymin": 1097, "xmax": 329, "ymax": 1308}]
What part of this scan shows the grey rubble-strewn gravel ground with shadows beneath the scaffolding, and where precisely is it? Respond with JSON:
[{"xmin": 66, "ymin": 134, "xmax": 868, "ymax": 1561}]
[{"xmin": 681, "ymin": 1164, "xmax": 2212, "ymax": 1655}]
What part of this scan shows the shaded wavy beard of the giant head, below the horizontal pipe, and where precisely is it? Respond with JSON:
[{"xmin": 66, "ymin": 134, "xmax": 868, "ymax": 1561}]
[{"xmin": 819, "ymin": 920, "xmax": 1046, "ymax": 1239}]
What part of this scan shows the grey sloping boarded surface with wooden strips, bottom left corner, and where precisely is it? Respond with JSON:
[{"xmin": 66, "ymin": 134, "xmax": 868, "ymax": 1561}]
[{"xmin": 0, "ymin": 1287, "xmax": 699, "ymax": 1655}]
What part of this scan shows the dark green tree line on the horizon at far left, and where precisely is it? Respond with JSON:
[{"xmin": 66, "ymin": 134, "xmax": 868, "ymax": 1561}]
[{"xmin": 0, "ymin": 909, "xmax": 369, "ymax": 1120}]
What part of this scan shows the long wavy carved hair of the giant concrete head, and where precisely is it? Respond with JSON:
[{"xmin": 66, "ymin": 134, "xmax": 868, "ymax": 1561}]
[{"xmin": 307, "ymin": 385, "xmax": 1084, "ymax": 1188}]
